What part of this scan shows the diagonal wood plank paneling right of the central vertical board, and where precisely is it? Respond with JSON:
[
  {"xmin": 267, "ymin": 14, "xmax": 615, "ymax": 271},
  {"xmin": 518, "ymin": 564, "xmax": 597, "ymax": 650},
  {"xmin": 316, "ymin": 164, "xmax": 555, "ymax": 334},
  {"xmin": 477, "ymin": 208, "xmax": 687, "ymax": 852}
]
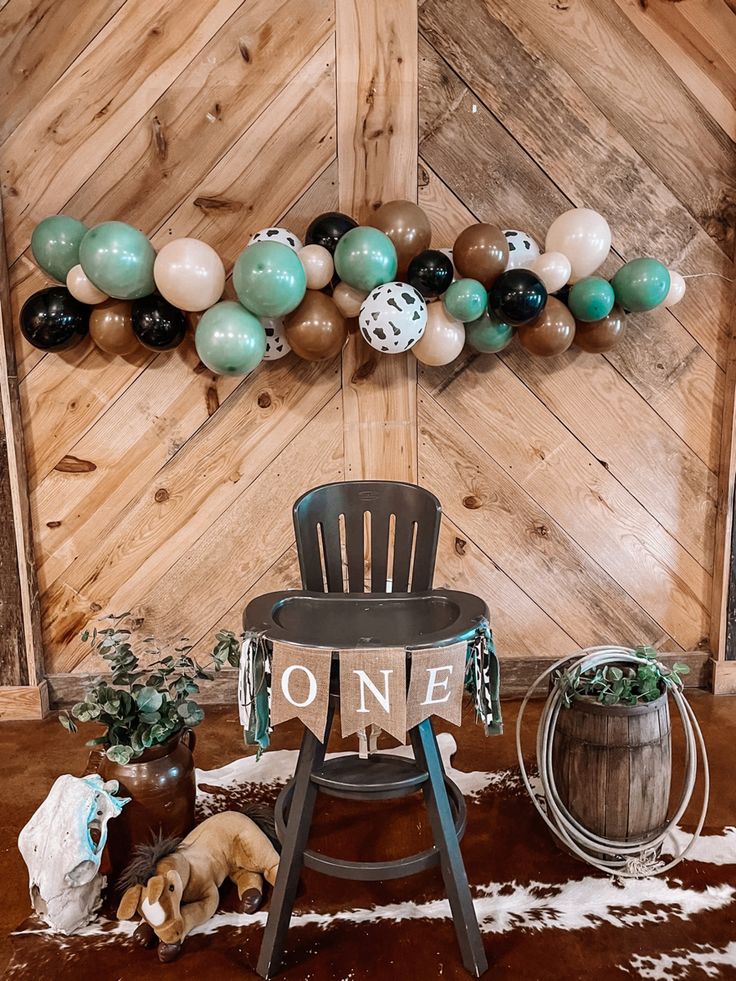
[{"xmin": 418, "ymin": 0, "xmax": 736, "ymax": 654}]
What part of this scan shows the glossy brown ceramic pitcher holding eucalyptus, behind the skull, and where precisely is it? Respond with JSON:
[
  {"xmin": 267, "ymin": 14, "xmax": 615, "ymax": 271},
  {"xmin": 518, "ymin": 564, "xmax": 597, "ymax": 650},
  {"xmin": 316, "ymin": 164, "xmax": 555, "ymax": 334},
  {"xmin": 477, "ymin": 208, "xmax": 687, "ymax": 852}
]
[{"xmin": 87, "ymin": 728, "xmax": 197, "ymax": 878}]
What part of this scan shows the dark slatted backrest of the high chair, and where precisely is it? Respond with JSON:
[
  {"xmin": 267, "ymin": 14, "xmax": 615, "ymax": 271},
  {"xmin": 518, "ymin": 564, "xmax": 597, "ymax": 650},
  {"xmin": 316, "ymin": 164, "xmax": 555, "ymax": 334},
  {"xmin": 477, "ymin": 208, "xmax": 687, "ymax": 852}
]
[{"xmin": 294, "ymin": 480, "xmax": 442, "ymax": 593}]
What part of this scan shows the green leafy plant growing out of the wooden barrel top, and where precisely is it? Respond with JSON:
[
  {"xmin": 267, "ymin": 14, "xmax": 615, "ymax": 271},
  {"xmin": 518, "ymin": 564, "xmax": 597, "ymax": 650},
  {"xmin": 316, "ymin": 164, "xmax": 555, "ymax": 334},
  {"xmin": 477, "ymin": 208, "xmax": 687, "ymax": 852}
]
[{"xmin": 555, "ymin": 647, "xmax": 690, "ymax": 708}]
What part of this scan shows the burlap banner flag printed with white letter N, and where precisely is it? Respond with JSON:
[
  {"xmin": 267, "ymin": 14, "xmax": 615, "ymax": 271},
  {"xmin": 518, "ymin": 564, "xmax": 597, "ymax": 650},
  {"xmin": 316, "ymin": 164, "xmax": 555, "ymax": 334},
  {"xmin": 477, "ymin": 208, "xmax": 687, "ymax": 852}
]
[{"xmin": 340, "ymin": 647, "xmax": 406, "ymax": 743}]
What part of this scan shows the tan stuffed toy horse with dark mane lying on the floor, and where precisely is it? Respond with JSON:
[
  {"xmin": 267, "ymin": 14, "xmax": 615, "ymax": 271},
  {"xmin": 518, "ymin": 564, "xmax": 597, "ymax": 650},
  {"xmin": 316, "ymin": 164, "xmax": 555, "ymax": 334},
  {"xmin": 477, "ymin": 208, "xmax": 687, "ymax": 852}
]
[{"xmin": 118, "ymin": 805, "xmax": 279, "ymax": 963}]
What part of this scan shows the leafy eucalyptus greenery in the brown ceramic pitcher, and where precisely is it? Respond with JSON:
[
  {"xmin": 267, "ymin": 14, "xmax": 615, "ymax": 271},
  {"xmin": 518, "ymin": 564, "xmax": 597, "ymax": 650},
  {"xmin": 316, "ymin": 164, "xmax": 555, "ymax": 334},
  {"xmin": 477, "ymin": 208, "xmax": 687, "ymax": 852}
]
[{"xmin": 59, "ymin": 613, "xmax": 240, "ymax": 763}]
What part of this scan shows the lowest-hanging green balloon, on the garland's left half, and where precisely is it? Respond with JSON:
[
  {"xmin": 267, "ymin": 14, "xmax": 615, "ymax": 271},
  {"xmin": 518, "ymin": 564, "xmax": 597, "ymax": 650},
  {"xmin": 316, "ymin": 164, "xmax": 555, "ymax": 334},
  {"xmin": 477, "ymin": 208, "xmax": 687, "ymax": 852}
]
[{"xmin": 194, "ymin": 298, "xmax": 270, "ymax": 375}]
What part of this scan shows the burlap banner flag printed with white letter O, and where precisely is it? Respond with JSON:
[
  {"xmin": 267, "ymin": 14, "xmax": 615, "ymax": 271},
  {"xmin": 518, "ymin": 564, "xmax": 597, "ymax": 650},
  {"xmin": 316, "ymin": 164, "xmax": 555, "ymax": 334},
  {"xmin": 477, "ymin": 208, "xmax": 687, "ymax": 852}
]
[{"xmin": 271, "ymin": 640, "xmax": 332, "ymax": 739}]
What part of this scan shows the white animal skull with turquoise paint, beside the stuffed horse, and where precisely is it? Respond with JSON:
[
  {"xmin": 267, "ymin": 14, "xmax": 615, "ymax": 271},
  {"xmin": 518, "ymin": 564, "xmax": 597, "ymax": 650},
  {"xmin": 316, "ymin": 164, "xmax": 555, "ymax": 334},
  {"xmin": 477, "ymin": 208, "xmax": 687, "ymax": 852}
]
[{"xmin": 18, "ymin": 774, "xmax": 130, "ymax": 934}]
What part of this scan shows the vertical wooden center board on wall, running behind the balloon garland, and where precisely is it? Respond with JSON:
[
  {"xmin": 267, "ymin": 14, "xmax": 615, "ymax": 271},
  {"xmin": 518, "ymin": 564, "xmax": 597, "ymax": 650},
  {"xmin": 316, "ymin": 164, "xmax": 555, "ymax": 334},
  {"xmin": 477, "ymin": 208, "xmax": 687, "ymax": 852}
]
[{"xmin": 336, "ymin": 0, "xmax": 417, "ymax": 483}]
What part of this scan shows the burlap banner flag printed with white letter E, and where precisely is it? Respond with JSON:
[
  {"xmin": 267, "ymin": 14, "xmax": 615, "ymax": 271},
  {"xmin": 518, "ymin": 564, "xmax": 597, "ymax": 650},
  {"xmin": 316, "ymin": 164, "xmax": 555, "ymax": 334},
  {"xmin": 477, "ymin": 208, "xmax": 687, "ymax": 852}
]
[{"xmin": 406, "ymin": 641, "xmax": 468, "ymax": 729}]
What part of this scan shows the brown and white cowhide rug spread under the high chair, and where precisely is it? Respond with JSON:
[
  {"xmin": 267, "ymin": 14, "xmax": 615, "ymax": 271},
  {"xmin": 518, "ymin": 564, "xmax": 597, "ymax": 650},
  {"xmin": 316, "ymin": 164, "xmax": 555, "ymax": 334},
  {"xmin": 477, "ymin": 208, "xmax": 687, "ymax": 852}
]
[{"xmin": 5, "ymin": 704, "xmax": 736, "ymax": 981}]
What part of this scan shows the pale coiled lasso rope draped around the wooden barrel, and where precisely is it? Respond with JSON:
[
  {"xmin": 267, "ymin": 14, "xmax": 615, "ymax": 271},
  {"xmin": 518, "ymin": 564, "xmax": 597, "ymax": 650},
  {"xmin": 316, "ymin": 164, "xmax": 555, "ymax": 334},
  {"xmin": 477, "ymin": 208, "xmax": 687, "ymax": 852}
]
[{"xmin": 516, "ymin": 647, "xmax": 710, "ymax": 878}]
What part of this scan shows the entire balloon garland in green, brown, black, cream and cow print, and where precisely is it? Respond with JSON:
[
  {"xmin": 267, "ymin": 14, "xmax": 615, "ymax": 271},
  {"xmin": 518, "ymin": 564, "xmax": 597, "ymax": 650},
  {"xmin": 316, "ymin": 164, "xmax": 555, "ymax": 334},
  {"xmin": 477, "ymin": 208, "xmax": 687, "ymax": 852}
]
[{"xmin": 20, "ymin": 201, "xmax": 685, "ymax": 376}]
